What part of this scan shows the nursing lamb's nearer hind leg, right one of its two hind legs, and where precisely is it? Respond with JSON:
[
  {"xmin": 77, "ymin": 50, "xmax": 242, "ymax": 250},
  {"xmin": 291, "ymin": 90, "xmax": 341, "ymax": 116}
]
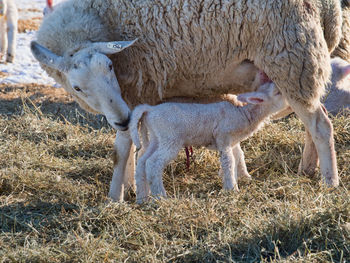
[{"xmin": 146, "ymin": 143, "xmax": 180, "ymax": 198}]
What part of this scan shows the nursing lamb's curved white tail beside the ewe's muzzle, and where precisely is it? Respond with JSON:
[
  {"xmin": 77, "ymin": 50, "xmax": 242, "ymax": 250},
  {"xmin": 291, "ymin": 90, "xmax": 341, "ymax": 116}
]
[{"xmin": 129, "ymin": 104, "xmax": 152, "ymax": 150}]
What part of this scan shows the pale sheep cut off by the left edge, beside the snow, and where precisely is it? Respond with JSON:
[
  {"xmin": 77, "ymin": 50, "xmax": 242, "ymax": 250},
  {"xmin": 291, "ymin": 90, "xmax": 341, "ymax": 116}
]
[{"xmin": 0, "ymin": 0, "xmax": 18, "ymax": 62}]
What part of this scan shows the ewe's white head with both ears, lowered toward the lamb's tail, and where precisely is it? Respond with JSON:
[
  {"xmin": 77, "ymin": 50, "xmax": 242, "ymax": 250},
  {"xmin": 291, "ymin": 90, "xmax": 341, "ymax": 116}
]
[{"xmin": 31, "ymin": 41, "xmax": 135, "ymax": 130}]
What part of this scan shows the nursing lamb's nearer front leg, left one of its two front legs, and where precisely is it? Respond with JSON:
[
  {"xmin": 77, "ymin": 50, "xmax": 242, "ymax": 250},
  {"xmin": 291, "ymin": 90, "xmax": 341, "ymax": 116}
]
[{"xmin": 220, "ymin": 146, "xmax": 238, "ymax": 191}]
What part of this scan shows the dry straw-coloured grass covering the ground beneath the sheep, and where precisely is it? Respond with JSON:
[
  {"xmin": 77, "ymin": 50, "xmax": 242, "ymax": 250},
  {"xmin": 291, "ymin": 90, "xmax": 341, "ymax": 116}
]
[{"xmin": 0, "ymin": 87, "xmax": 350, "ymax": 262}]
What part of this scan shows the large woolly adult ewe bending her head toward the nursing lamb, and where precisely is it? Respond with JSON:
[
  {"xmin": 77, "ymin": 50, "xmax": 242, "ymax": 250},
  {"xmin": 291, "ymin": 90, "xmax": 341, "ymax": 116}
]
[{"xmin": 31, "ymin": 0, "xmax": 341, "ymax": 200}]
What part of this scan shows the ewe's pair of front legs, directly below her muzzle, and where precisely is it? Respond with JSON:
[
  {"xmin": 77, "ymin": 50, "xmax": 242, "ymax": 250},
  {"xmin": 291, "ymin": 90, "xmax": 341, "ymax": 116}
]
[{"xmin": 108, "ymin": 132, "xmax": 134, "ymax": 201}]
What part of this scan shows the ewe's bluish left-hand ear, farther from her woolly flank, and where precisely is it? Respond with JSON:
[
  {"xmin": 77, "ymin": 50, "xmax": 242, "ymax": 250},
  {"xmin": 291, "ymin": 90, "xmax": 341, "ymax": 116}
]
[{"xmin": 30, "ymin": 41, "xmax": 64, "ymax": 71}]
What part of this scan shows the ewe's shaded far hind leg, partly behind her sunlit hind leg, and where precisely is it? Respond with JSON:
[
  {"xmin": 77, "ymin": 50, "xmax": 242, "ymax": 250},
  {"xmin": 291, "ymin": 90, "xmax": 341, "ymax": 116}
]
[{"xmin": 298, "ymin": 130, "xmax": 319, "ymax": 176}]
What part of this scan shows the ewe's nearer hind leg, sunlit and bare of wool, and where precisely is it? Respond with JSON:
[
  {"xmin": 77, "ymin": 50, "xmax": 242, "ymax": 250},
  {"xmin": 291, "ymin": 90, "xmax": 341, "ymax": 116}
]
[{"xmin": 291, "ymin": 104, "xmax": 339, "ymax": 186}]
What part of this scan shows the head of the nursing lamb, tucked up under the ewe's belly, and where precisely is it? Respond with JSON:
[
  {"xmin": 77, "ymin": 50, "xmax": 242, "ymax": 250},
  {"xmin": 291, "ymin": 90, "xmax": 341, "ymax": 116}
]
[{"xmin": 237, "ymin": 82, "xmax": 288, "ymax": 114}]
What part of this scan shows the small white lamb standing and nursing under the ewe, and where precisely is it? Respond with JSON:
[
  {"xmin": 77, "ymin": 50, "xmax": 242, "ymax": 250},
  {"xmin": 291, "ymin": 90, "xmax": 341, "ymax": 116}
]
[{"xmin": 130, "ymin": 83, "xmax": 287, "ymax": 202}]
